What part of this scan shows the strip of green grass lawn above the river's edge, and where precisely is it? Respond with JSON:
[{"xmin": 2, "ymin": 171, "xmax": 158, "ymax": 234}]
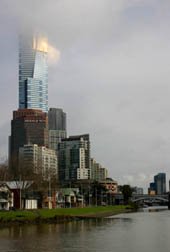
[{"xmin": 0, "ymin": 206, "xmax": 127, "ymax": 224}]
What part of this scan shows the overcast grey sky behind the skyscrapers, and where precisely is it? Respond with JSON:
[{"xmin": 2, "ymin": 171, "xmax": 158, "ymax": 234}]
[{"xmin": 0, "ymin": 0, "xmax": 170, "ymax": 188}]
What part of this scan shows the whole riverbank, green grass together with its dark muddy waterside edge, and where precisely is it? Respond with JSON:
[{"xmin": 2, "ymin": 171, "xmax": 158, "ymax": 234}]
[{"xmin": 0, "ymin": 205, "xmax": 132, "ymax": 227}]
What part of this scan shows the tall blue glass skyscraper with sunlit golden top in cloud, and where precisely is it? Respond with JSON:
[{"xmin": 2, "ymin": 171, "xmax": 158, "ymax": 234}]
[{"xmin": 19, "ymin": 35, "xmax": 48, "ymax": 112}]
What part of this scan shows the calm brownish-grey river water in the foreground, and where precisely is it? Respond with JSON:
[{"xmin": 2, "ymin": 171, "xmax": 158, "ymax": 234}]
[{"xmin": 0, "ymin": 211, "xmax": 170, "ymax": 252}]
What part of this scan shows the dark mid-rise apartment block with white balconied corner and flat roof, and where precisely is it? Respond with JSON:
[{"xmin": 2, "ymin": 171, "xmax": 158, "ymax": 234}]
[{"xmin": 58, "ymin": 134, "xmax": 91, "ymax": 181}]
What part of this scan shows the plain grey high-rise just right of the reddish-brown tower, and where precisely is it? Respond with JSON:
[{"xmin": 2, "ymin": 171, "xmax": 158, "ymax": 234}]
[{"xmin": 48, "ymin": 108, "xmax": 67, "ymax": 152}]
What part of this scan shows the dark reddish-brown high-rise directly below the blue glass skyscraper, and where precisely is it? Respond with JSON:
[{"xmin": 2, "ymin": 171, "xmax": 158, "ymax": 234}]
[{"xmin": 9, "ymin": 109, "xmax": 48, "ymax": 171}]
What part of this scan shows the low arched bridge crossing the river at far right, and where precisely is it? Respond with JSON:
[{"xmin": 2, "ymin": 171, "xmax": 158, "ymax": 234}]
[{"xmin": 131, "ymin": 194, "xmax": 169, "ymax": 206}]
